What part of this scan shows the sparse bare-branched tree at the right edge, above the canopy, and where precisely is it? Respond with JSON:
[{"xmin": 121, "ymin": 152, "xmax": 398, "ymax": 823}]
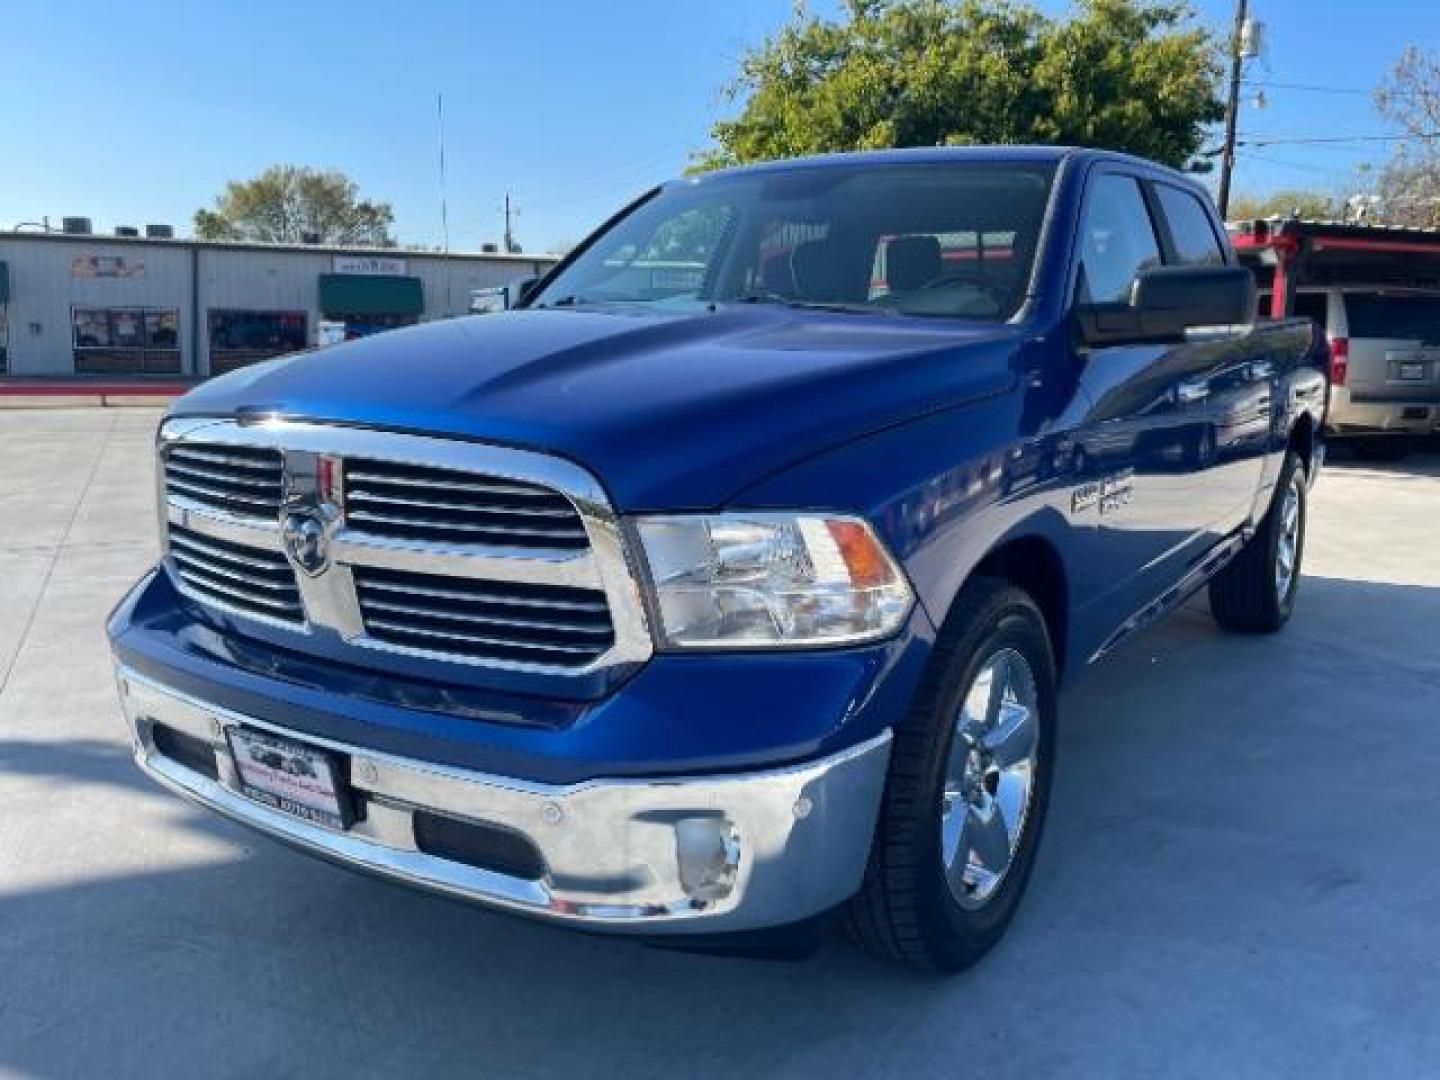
[{"xmin": 1375, "ymin": 46, "xmax": 1440, "ymax": 228}]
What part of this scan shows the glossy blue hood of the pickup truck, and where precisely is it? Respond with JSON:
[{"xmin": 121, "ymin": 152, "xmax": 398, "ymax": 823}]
[{"xmin": 171, "ymin": 305, "xmax": 1018, "ymax": 511}]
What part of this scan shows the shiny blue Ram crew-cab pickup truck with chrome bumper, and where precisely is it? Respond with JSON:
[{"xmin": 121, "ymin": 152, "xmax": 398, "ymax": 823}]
[{"xmin": 109, "ymin": 147, "xmax": 1328, "ymax": 971}]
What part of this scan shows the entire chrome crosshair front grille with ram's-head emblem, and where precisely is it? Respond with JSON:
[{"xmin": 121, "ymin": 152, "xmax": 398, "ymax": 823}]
[{"xmin": 157, "ymin": 418, "xmax": 652, "ymax": 677}]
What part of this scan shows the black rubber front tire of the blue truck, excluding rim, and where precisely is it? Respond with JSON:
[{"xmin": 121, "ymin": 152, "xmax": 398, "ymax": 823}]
[{"xmin": 844, "ymin": 577, "xmax": 1056, "ymax": 972}]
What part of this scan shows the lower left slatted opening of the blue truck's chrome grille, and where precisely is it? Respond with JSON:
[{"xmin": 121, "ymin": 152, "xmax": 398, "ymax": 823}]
[{"xmin": 170, "ymin": 521, "xmax": 305, "ymax": 626}]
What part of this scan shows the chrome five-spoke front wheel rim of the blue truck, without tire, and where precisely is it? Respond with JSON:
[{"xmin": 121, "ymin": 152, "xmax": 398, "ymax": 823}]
[{"xmin": 940, "ymin": 648, "xmax": 1040, "ymax": 910}]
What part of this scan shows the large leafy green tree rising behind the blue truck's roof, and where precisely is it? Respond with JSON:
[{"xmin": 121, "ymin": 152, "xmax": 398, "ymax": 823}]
[{"xmin": 697, "ymin": 0, "xmax": 1224, "ymax": 168}]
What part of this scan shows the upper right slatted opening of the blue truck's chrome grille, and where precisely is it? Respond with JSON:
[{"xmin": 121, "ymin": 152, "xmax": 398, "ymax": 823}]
[{"xmin": 344, "ymin": 461, "xmax": 589, "ymax": 550}]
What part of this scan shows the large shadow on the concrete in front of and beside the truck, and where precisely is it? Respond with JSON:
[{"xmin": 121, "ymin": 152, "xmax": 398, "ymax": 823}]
[{"xmin": 0, "ymin": 577, "xmax": 1440, "ymax": 1077}]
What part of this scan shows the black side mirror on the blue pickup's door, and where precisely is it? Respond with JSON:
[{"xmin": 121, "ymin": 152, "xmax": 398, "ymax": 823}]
[{"xmin": 1076, "ymin": 266, "xmax": 1256, "ymax": 346}]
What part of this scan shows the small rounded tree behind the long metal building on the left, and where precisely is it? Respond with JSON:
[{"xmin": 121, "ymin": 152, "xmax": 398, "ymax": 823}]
[{"xmin": 194, "ymin": 166, "xmax": 395, "ymax": 246}]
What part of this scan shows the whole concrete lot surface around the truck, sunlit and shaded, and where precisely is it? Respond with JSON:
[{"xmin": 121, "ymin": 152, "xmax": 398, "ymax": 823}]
[{"xmin": 0, "ymin": 409, "xmax": 1440, "ymax": 1077}]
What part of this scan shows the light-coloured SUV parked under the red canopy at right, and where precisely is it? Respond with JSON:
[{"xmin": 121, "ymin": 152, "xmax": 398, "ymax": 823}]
[{"xmin": 1259, "ymin": 285, "xmax": 1440, "ymax": 459}]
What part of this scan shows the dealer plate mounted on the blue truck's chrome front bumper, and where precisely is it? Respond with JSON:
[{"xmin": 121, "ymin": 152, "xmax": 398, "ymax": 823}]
[{"xmin": 229, "ymin": 727, "xmax": 350, "ymax": 829}]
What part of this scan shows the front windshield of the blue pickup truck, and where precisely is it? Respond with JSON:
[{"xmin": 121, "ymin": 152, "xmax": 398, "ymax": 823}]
[{"xmin": 531, "ymin": 163, "xmax": 1054, "ymax": 321}]
